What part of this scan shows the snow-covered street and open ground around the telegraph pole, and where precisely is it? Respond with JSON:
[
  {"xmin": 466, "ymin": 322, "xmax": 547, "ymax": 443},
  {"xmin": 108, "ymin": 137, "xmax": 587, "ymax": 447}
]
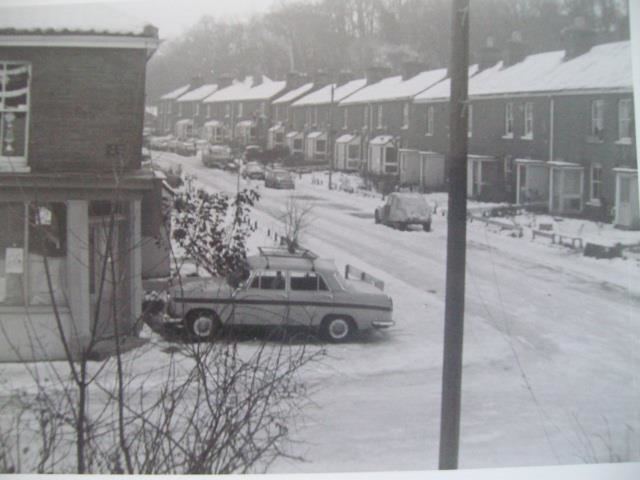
[{"xmin": 0, "ymin": 152, "xmax": 640, "ymax": 473}]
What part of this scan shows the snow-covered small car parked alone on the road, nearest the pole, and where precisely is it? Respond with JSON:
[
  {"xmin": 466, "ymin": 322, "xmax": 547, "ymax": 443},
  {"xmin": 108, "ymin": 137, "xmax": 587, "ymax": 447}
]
[{"xmin": 374, "ymin": 192, "xmax": 431, "ymax": 232}]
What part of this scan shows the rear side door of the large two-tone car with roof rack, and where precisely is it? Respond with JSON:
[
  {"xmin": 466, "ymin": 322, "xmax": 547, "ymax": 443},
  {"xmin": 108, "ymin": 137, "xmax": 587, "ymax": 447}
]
[{"xmin": 289, "ymin": 271, "xmax": 333, "ymax": 326}]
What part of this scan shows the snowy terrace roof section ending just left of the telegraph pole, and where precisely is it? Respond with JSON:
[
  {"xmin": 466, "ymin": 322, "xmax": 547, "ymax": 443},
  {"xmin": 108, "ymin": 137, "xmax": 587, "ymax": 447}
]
[{"xmin": 340, "ymin": 68, "xmax": 447, "ymax": 105}]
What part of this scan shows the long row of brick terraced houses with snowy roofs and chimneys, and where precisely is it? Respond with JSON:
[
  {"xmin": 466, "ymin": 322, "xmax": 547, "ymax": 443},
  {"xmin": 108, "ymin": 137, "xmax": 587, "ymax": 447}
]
[{"xmin": 160, "ymin": 23, "xmax": 640, "ymax": 229}]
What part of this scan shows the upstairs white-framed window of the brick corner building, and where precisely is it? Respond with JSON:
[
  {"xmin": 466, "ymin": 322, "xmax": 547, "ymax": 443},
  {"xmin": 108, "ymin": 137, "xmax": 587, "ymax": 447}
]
[{"xmin": 0, "ymin": 62, "xmax": 31, "ymax": 170}]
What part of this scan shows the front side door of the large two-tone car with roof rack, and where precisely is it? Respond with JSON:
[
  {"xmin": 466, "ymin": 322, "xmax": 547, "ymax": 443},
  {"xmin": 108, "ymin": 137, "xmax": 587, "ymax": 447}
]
[{"xmin": 231, "ymin": 270, "xmax": 288, "ymax": 325}]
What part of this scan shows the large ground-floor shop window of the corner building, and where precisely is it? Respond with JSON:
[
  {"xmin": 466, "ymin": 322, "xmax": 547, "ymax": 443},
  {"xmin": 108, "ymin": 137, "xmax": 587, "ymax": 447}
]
[{"xmin": 0, "ymin": 203, "xmax": 67, "ymax": 306}]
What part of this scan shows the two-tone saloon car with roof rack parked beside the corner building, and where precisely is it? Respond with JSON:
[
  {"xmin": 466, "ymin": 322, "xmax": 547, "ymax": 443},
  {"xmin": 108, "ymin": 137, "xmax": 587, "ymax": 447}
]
[{"xmin": 167, "ymin": 248, "xmax": 395, "ymax": 343}]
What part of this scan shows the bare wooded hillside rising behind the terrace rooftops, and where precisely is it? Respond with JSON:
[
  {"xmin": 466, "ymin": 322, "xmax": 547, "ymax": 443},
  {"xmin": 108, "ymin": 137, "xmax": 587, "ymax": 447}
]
[{"xmin": 147, "ymin": 0, "xmax": 629, "ymax": 103}]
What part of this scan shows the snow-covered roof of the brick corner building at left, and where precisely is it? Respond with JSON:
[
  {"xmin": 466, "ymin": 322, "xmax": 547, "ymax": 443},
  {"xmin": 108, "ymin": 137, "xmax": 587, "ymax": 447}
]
[{"xmin": 0, "ymin": 3, "xmax": 158, "ymax": 38}]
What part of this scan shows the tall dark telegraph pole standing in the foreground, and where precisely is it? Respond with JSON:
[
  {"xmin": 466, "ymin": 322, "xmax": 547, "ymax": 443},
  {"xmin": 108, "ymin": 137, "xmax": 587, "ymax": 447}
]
[{"xmin": 439, "ymin": 0, "xmax": 469, "ymax": 470}]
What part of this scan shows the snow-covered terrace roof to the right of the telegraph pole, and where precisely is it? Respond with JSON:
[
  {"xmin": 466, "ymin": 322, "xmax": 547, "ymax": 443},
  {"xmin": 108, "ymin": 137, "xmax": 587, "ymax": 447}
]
[{"xmin": 469, "ymin": 41, "xmax": 632, "ymax": 96}]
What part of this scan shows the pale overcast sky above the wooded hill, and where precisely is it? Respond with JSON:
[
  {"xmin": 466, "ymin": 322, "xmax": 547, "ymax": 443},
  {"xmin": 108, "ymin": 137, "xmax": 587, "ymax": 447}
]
[{"xmin": 0, "ymin": 0, "xmax": 282, "ymax": 38}]
